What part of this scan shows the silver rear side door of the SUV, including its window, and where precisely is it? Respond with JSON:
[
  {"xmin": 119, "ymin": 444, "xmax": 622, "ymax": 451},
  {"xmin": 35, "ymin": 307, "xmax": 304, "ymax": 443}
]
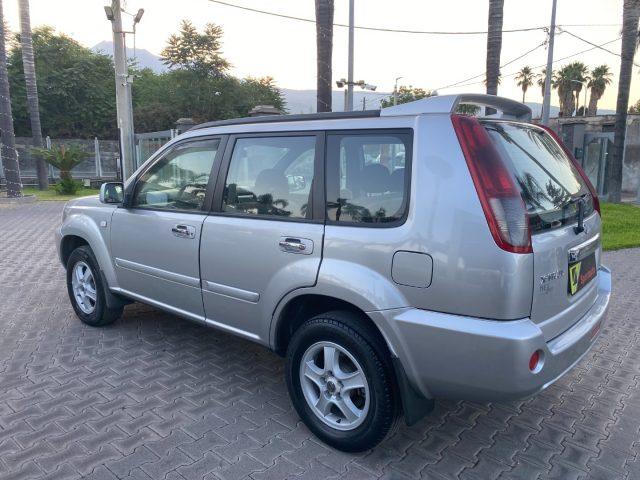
[{"xmin": 200, "ymin": 133, "xmax": 324, "ymax": 343}]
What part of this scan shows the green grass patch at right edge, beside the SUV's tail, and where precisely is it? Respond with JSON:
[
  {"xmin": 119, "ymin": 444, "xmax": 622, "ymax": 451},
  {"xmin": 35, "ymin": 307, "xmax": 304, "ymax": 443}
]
[{"xmin": 601, "ymin": 203, "xmax": 640, "ymax": 250}]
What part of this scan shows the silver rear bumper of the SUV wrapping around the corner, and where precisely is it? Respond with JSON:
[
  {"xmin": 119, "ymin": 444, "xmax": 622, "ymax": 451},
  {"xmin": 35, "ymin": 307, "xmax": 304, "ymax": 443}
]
[{"xmin": 370, "ymin": 267, "xmax": 611, "ymax": 401}]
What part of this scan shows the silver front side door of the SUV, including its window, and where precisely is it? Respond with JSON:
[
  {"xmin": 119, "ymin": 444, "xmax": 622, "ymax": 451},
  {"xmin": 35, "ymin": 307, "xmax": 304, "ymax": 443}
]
[{"xmin": 111, "ymin": 139, "xmax": 220, "ymax": 321}]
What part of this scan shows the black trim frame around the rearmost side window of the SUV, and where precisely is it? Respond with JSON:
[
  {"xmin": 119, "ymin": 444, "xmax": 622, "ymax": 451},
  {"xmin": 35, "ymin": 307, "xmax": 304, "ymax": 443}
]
[{"xmin": 324, "ymin": 128, "xmax": 414, "ymax": 228}]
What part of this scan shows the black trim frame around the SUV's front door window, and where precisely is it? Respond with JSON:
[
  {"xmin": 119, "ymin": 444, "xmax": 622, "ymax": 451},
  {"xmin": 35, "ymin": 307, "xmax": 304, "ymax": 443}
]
[{"xmin": 124, "ymin": 135, "xmax": 228, "ymax": 215}]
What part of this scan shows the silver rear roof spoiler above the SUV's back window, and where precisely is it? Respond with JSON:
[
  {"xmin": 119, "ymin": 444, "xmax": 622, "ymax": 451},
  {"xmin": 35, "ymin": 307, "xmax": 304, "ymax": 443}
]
[{"xmin": 380, "ymin": 93, "xmax": 531, "ymax": 122}]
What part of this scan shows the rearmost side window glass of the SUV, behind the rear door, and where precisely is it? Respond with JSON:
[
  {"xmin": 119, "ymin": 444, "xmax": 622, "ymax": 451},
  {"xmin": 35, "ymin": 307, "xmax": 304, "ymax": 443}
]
[{"xmin": 326, "ymin": 129, "xmax": 411, "ymax": 225}]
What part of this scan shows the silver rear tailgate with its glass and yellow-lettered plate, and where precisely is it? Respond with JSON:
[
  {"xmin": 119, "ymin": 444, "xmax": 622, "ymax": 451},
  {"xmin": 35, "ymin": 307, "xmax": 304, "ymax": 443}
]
[{"xmin": 484, "ymin": 122, "xmax": 601, "ymax": 340}]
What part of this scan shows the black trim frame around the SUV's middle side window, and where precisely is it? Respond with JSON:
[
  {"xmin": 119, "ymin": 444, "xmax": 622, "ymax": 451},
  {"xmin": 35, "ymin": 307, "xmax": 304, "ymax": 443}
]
[{"xmin": 209, "ymin": 130, "xmax": 325, "ymax": 224}]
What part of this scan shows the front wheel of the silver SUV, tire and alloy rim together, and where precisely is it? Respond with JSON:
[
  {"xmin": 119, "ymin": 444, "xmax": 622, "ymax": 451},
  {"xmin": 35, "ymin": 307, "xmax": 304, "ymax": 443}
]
[{"xmin": 67, "ymin": 245, "xmax": 123, "ymax": 327}]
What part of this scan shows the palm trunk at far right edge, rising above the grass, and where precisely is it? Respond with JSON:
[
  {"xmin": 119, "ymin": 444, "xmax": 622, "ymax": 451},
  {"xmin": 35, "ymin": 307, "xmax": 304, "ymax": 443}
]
[{"xmin": 607, "ymin": 0, "xmax": 640, "ymax": 203}]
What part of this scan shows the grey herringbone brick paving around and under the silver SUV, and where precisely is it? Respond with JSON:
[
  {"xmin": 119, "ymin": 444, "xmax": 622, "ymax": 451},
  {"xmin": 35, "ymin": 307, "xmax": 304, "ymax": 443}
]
[{"xmin": 0, "ymin": 203, "xmax": 640, "ymax": 480}]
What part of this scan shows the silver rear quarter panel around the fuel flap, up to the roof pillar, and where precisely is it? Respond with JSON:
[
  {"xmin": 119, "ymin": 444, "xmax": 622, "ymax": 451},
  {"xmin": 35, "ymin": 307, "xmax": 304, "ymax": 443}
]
[{"xmin": 318, "ymin": 115, "xmax": 533, "ymax": 320}]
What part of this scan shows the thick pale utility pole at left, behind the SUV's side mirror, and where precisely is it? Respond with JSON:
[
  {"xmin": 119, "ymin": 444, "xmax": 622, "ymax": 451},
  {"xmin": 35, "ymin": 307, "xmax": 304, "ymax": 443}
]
[{"xmin": 104, "ymin": 0, "xmax": 135, "ymax": 181}]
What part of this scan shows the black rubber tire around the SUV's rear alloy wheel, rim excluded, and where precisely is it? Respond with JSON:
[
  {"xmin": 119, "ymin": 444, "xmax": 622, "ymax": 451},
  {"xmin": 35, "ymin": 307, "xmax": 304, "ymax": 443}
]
[{"xmin": 286, "ymin": 316, "xmax": 395, "ymax": 452}]
